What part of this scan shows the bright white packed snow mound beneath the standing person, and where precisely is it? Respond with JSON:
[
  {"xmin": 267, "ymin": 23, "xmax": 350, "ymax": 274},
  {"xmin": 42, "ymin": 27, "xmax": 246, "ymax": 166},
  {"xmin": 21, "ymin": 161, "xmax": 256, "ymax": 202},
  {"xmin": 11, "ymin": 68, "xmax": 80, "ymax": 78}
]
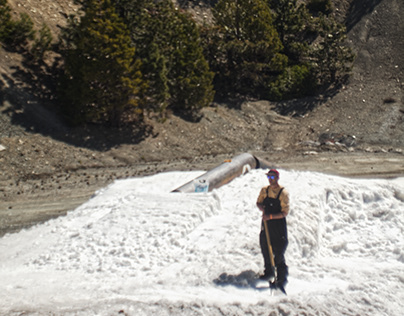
[{"xmin": 0, "ymin": 170, "xmax": 404, "ymax": 316}]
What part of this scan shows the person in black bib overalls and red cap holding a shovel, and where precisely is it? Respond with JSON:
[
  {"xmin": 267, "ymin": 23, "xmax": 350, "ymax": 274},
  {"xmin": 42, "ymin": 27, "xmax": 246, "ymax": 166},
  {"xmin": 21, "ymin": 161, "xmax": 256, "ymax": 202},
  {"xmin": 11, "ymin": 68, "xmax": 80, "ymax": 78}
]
[{"xmin": 257, "ymin": 169, "xmax": 289, "ymax": 291}]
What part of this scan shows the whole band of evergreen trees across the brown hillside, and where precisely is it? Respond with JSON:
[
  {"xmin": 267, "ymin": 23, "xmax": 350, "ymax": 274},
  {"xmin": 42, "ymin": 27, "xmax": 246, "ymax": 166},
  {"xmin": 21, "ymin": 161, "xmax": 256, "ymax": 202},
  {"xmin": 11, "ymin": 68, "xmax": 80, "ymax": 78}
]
[{"xmin": 0, "ymin": 0, "xmax": 354, "ymax": 126}]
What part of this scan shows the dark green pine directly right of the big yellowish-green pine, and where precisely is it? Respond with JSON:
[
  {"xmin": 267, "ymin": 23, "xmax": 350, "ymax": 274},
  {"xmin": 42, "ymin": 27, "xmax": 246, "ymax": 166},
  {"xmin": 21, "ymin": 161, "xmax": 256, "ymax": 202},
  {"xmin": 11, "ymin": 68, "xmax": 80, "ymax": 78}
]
[{"xmin": 115, "ymin": 0, "xmax": 214, "ymax": 116}]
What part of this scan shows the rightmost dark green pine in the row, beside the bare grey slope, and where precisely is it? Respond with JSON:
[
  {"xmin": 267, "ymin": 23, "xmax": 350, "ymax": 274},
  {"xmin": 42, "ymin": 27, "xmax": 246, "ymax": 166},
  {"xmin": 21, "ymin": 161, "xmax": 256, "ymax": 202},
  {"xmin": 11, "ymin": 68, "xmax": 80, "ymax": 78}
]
[{"xmin": 267, "ymin": 0, "xmax": 354, "ymax": 99}]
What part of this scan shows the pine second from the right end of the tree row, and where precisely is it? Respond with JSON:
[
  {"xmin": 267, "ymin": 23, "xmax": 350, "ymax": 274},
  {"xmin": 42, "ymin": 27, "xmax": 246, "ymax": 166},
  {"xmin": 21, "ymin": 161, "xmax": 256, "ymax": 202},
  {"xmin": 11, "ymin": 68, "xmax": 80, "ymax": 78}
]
[{"xmin": 208, "ymin": 0, "xmax": 287, "ymax": 97}]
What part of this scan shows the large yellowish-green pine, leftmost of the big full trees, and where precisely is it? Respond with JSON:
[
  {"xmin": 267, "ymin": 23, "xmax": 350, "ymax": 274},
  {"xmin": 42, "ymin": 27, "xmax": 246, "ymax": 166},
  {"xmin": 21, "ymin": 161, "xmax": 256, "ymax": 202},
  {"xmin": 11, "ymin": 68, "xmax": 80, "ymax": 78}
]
[{"xmin": 62, "ymin": 0, "xmax": 143, "ymax": 126}]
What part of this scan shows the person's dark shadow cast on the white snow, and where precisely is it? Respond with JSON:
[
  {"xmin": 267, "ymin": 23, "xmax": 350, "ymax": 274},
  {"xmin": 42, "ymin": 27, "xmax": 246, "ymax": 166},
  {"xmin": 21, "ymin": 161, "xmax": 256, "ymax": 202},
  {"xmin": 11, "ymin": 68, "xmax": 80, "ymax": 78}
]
[{"xmin": 213, "ymin": 270, "xmax": 268, "ymax": 290}]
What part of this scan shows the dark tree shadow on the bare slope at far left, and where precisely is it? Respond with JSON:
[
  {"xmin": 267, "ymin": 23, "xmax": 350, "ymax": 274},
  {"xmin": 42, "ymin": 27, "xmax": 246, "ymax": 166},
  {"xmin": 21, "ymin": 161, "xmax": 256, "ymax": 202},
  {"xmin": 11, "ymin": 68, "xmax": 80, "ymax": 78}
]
[{"xmin": 0, "ymin": 50, "xmax": 153, "ymax": 151}]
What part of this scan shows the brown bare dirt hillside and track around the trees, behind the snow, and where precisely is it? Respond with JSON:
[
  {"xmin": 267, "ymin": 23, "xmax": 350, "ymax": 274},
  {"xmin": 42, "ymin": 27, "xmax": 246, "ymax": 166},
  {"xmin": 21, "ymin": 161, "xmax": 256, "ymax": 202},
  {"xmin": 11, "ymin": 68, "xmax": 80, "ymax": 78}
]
[{"xmin": 0, "ymin": 0, "xmax": 404, "ymax": 236}]
